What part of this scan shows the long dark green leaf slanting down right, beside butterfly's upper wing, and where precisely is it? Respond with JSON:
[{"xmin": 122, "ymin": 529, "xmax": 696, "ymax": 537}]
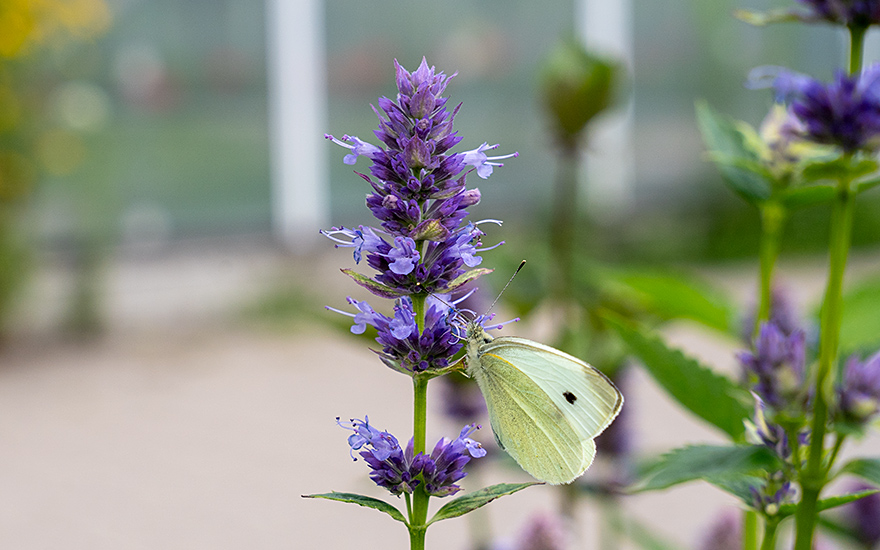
[{"xmin": 602, "ymin": 312, "xmax": 751, "ymax": 439}]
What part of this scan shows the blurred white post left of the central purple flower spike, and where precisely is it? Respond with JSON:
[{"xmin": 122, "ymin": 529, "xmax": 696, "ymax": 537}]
[{"xmin": 266, "ymin": 0, "xmax": 329, "ymax": 251}]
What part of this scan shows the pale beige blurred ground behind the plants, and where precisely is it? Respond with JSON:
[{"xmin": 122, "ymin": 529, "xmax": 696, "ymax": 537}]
[{"xmin": 0, "ymin": 246, "xmax": 880, "ymax": 550}]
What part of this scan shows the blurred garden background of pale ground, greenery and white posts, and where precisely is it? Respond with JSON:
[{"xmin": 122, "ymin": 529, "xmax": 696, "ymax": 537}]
[{"xmin": 0, "ymin": 0, "xmax": 880, "ymax": 549}]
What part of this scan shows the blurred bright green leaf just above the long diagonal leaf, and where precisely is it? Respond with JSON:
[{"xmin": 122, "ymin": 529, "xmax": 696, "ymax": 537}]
[{"xmin": 599, "ymin": 269, "xmax": 737, "ymax": 332}]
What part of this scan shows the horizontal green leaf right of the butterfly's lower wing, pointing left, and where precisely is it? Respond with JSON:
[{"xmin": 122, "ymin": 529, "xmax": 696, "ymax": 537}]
[{"xmin": 636, "ymin": 445, "xmax": 781, "ymax": 496}]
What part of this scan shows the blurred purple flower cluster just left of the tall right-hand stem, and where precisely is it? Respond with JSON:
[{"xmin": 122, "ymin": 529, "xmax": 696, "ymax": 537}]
[{"xmin": 737, "ymin": 322, "xmax": 806, "ymax": 411}]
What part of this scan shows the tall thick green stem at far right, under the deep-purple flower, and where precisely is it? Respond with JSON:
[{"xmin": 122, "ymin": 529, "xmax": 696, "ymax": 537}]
[{"xmin": 795, "ymin": 179, "xmax": 855, "ymax": 550}]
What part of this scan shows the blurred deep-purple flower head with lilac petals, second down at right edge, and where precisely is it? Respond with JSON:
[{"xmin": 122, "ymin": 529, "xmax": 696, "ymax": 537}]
[{"xmin": 748, "ymin": 64, "xmax": 880, "ymax": 153}]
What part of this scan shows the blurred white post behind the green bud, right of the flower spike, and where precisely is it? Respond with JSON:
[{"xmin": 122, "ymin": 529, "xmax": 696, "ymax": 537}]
[{"xmin": 575, "ymin": 0, "xmax": 635, "ymax": 218}]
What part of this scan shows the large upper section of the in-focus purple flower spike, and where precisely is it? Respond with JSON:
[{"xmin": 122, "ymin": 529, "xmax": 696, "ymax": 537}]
[{"xmin": 323, "ymin": 59, "xmax": 517, "ymax": 304}]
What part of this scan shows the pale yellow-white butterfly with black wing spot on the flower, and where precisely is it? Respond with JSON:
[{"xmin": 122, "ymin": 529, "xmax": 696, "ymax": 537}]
[{"xmin": 465, "ymin": 321, "xmax": 623, "ymax": 485}]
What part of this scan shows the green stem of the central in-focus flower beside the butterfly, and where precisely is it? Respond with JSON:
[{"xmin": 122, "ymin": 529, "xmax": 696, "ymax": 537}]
[{"xmin": 409, "ymin": 294, "xmax": 430, "ymax": 550}]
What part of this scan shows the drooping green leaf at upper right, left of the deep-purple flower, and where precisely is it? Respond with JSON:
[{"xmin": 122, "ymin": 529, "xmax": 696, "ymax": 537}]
[{"xmin": 697, "ymin": 101, "xmax": 772, "ymax": 204}]
